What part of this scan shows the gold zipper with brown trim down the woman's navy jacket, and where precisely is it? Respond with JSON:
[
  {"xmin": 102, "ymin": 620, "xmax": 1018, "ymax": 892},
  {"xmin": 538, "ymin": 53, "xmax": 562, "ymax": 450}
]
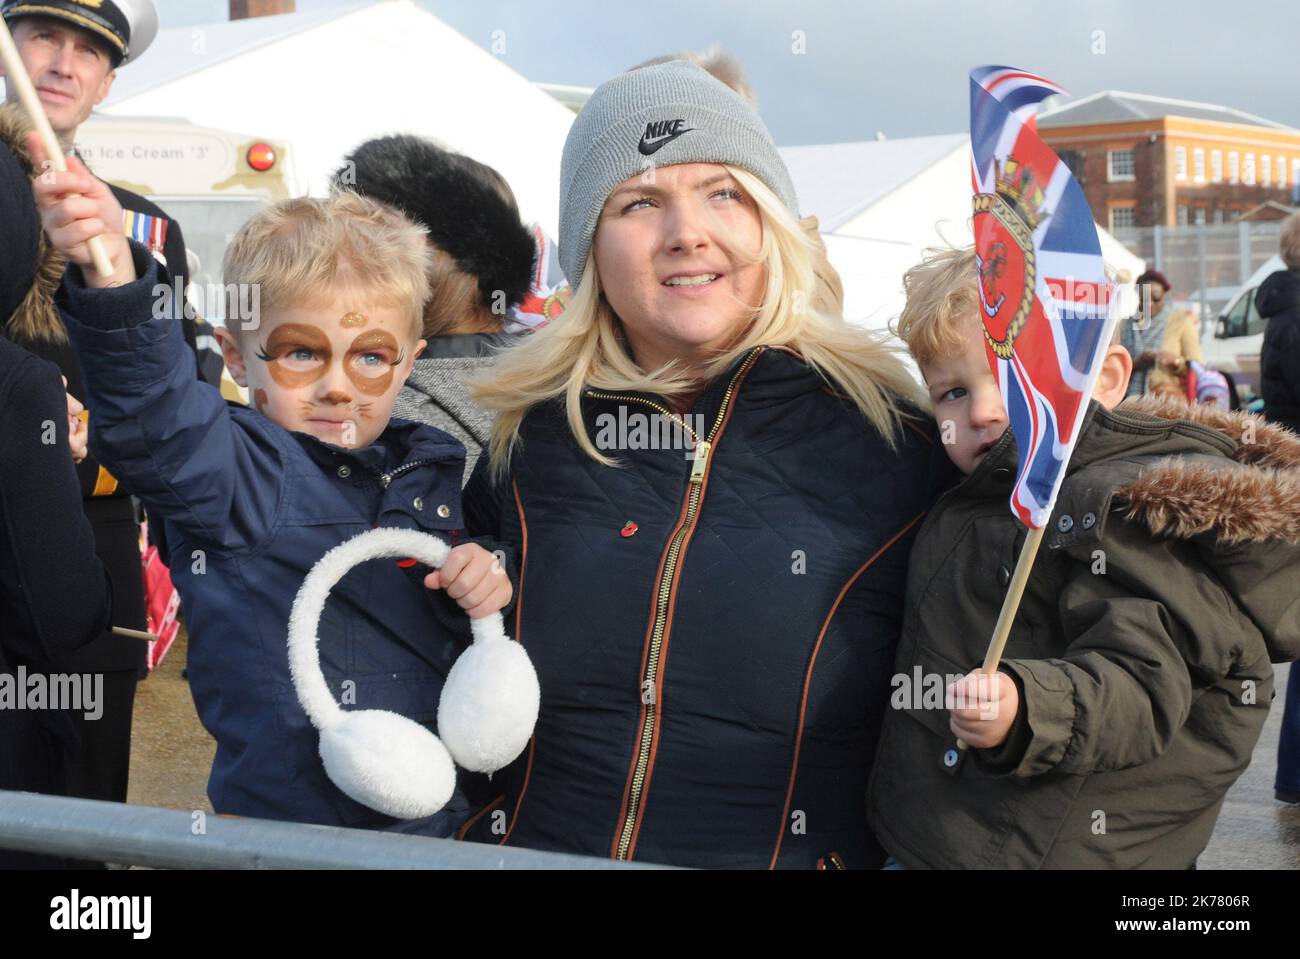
[{"xmin": 585, "ymin": 347, "xmax": 763, "ymax": 860}]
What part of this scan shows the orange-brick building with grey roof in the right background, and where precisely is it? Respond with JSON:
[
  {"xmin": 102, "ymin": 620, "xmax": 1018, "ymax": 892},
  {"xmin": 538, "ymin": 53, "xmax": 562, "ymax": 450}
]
[{"xmin": 1039, "ymin": 90, "xmax": 1300, "ymax": 231}]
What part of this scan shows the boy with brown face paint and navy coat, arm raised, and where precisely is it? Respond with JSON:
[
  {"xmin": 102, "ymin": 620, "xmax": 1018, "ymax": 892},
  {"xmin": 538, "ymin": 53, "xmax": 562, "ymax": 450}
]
[{"xmin": 31, "ymin": 142, "xmax": 512, "ymax": 836}]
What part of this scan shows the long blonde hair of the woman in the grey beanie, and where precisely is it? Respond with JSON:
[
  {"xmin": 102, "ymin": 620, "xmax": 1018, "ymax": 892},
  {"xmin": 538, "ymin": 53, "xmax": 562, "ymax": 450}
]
[{"xmin": 473, "ymin": 166, "xmax": 920, "ymax": 477}]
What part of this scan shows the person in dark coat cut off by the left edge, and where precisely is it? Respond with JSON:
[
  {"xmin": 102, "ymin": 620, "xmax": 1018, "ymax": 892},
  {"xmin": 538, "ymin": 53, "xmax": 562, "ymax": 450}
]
[{"xmin": 0, "ymin": 132, "xmax": 112, "ymax": 868}]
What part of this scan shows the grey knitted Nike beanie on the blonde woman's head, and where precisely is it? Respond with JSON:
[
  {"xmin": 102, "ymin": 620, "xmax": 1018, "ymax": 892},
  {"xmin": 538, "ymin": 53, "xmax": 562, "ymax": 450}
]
[{"xmin": 560, "ymin": 60, "xmax": 798, "ymax": 290}]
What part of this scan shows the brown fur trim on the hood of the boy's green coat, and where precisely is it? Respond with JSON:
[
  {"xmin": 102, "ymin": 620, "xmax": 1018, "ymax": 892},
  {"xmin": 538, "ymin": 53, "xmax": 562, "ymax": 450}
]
[{"xmin": 1115, "ymin": 396, "xmax": 1300, "ymax": 546}]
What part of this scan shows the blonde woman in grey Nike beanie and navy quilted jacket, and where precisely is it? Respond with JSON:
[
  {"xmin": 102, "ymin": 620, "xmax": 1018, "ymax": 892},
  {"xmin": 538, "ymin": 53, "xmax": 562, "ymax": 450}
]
[{"xmin": 462, "ymin": 61, "xmax": 948, "ymax": 868}]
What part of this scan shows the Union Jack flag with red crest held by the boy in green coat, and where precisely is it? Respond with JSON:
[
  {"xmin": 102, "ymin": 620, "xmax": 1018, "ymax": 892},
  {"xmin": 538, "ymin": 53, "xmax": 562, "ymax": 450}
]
[{"xmin": 971, "ymin": 66, "xmax": 1114, "ymax": 529}]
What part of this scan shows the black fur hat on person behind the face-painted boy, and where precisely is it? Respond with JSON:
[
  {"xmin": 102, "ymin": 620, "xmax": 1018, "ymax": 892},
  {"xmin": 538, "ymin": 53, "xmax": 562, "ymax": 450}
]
[{"xmin": 333, "ymin": 134, "xmax": 536, "ymax": 308}]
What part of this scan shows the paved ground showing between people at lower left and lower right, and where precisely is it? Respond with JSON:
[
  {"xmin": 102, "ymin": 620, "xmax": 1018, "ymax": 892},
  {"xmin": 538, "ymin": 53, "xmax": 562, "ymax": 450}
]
[{"xmin": 130, "ymin": 630, "xmax": 1300, "ymax": 869}]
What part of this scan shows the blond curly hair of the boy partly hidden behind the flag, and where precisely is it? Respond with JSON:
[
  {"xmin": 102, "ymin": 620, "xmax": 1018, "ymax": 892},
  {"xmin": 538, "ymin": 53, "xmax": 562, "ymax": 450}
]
[{"xmin": 896, "ymin": 246, "xmax": 979, "ymax": 364}]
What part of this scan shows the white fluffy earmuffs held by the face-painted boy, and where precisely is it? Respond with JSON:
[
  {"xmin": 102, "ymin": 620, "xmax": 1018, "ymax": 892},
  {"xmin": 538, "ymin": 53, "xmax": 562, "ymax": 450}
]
[{"xmin": 289, "ymin": 528, "xmax": 541, "ymax": 819}]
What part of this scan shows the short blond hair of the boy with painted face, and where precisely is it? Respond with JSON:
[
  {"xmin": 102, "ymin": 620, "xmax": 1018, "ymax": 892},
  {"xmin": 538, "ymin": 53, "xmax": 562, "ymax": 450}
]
[{"xmin": 222, "ymin": 192, "xmax": 432, "ymax": 338}]
